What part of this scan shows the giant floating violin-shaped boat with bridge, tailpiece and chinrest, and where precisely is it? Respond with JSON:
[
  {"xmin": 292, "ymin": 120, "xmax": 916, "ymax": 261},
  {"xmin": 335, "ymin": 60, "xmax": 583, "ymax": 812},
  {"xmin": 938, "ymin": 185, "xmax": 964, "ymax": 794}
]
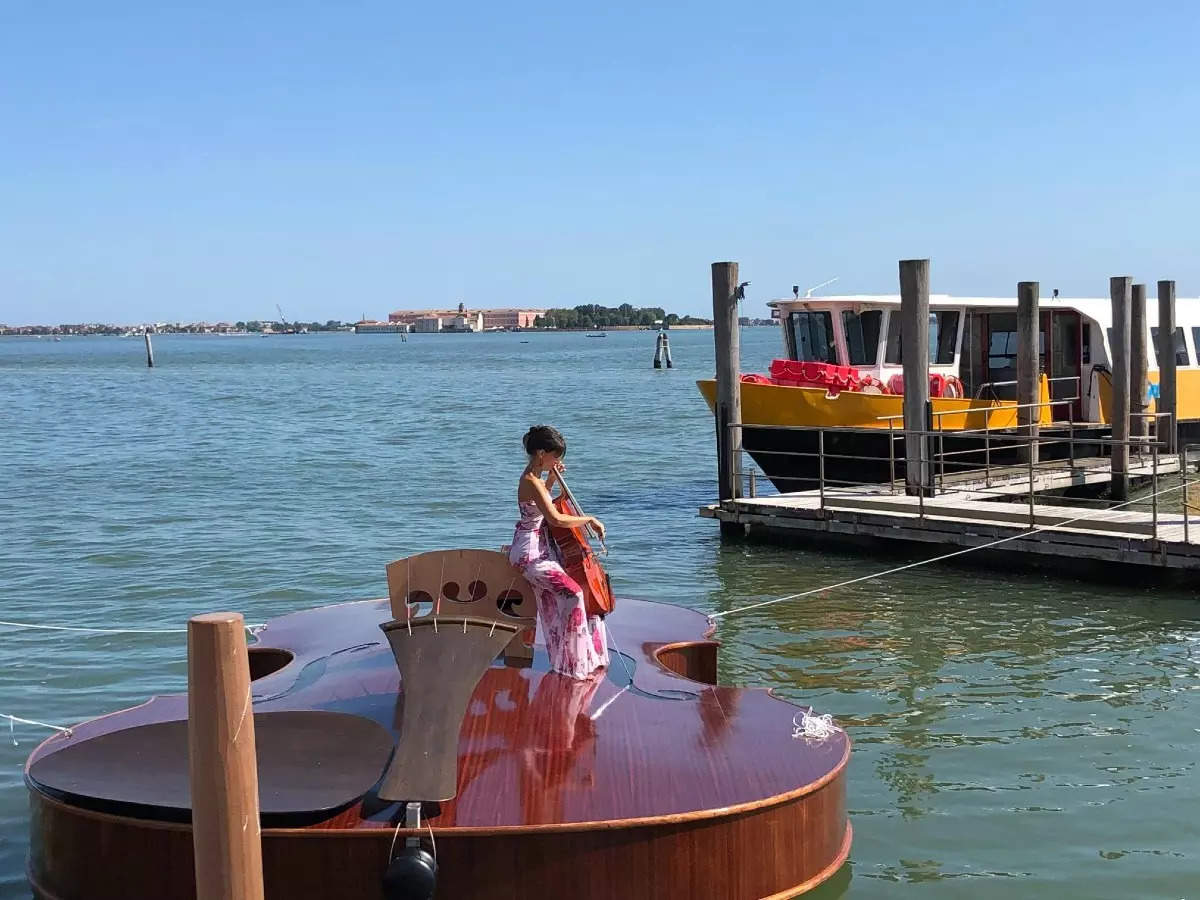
[{"xmin": 25, "ymin": 550, "xmax": 851, "ymax": 900}]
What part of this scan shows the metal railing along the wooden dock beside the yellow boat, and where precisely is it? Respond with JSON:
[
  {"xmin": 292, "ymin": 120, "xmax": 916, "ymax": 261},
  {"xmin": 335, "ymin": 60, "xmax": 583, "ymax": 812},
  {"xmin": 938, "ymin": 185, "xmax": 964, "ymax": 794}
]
[{"xmin": 728, "ymin": 415, "xmax": 1185, "ymax": 540}]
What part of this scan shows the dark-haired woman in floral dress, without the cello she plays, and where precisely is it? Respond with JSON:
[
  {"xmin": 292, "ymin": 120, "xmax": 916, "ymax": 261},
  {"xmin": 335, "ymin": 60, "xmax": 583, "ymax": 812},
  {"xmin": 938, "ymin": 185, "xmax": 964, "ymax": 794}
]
[{"xmin": 509, "ymin": 425, "xmax": 608, "ymax": 678}]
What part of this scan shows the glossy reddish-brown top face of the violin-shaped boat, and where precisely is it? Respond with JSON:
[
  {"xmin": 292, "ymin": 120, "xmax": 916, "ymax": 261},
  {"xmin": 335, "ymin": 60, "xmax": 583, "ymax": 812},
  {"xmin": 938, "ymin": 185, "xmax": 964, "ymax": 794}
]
[{"xmin": 31, "ymin": 600, "xmax": 848, "ymax": 828}]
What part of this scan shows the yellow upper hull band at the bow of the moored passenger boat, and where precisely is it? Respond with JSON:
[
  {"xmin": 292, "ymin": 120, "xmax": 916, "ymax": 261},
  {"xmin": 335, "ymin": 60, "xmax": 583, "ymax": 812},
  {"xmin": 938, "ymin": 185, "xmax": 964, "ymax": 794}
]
[{"xmin": 696, "ymin": 378, "xmax": 1051, "ymax": 431}]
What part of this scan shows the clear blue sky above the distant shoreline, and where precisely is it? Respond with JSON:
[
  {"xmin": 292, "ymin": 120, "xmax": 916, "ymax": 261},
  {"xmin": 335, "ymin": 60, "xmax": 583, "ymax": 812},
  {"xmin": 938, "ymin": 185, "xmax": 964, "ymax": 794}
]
[{"xmin": 0, "ymin": 0, "xmax": 1200, "ymax": 325}]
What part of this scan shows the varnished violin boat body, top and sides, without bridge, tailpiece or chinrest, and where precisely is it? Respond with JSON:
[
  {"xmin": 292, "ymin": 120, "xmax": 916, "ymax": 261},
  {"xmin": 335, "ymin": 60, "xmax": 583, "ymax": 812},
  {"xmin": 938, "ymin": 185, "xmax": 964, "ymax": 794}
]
[{"xmin": 26, "ymin": 588, "xmax": 850, "ymax": 900}]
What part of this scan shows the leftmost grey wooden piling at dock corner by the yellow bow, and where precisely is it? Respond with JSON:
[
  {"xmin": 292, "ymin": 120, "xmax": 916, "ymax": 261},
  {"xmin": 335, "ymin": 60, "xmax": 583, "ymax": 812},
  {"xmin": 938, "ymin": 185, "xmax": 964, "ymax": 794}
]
[{"xmin": 713, "ymin": 263, "xmax": 743, "ymax": 534}]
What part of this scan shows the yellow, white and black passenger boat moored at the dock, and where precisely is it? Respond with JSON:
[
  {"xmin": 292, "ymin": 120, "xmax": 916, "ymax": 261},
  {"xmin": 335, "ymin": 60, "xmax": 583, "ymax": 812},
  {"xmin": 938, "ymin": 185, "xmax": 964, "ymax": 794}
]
[{"xmin": 697, "ymin": 294, "xmax": 1200, "ymax": 491}]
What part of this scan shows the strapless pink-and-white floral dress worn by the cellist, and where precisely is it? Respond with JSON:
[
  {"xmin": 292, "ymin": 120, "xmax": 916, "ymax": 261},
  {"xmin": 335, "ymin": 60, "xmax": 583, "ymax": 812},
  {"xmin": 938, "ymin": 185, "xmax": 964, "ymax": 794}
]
[{"xmin": 509, "ymin": 500, "xmax": 608, "ymax": 678}]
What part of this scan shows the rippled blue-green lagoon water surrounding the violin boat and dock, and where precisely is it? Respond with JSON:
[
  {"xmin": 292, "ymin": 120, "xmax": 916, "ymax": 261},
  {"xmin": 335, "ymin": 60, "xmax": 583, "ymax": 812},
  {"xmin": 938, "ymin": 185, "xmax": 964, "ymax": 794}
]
[{"xmin": 0, "ymin": 329, "xmax": 1200, "ymax": 900}]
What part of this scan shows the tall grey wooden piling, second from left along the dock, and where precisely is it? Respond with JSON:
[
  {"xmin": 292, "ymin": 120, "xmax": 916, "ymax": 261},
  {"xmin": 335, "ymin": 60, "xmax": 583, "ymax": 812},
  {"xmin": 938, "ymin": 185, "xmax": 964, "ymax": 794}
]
[{"xmin": 900, "ymin": 259, "xmax": 930, "ymax": 497}]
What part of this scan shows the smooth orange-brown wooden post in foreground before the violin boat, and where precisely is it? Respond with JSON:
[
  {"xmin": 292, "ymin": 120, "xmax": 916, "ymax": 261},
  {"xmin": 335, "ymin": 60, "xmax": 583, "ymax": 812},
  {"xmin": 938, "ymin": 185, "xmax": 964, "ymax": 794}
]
[{"xmin": 187, "ymin": 612, "xmax": 263, "ymax": 900}]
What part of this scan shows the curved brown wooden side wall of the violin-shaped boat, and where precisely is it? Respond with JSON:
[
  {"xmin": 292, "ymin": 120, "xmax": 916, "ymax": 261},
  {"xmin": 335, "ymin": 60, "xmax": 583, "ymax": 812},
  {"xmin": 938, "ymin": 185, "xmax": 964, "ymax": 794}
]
[{"xmin": 30, "ymin": 774, "xmax": 851, "ymax": 900}]
